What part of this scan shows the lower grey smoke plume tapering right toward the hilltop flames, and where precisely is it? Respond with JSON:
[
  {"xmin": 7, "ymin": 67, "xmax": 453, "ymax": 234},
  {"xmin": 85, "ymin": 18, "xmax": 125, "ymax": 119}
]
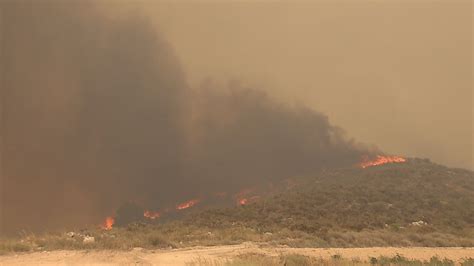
[{"xmin": 186, "ymin": 83, "xmax": 361, "ymax": 189}]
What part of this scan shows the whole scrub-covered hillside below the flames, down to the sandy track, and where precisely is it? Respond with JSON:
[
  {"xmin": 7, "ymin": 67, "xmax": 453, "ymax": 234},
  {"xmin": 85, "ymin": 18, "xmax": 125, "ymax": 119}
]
[{"xmin": 0, "ymin": 159, "xmax": 474, "ymax": 254}]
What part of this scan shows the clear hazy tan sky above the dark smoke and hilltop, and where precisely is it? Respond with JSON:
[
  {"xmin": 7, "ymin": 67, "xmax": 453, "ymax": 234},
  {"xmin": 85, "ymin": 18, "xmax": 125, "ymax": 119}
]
[{"xmin": 131, "ymin": 1, "xmax": 474, "ymax": 169}]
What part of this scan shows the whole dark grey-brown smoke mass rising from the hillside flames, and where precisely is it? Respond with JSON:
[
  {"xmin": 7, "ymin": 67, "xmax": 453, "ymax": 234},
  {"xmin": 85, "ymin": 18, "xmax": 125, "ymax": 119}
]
[{"xmin": 0, "ymin": 1, "xmax": 367, "ymax": 232}]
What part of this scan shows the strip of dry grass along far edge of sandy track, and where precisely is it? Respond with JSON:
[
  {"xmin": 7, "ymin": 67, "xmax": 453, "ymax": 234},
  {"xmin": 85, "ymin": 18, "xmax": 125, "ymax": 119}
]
[{"xmin": 0, "ymin": 222, "xmax": 474, "ymax": 254}]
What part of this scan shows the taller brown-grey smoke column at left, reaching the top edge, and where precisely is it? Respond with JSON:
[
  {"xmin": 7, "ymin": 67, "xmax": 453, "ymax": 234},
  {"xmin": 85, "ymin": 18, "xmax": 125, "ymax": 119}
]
[{"xmin": 2, "ymin": 2, "xmax": 186, "ymax": 233}]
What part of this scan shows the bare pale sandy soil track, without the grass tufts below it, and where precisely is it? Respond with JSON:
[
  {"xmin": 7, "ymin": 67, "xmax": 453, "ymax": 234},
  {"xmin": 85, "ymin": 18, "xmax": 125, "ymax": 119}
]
[{"xmin": 0, "ymin": 243, "xmax": 474, "ymax": 265}]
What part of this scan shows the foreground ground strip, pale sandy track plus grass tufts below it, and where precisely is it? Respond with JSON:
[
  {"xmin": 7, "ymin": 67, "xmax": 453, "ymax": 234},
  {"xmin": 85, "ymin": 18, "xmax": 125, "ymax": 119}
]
[{"xmin": 0, "ymin": 242, "xmax": 474, "ymax": 265}]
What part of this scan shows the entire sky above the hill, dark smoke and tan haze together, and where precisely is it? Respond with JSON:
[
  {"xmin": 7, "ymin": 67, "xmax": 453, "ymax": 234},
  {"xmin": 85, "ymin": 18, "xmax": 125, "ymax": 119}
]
[{"xmin": 0, "ymin": 1, "xmax": 473, "ymax": 232}]
